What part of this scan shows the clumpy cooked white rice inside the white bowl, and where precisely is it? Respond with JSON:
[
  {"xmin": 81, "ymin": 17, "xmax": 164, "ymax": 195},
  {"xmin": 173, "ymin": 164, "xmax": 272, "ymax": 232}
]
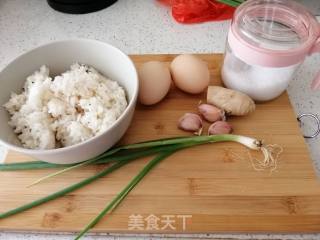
[{"xmin": 4, "ymin": 63, "xmax": 127, "ymax": 149}]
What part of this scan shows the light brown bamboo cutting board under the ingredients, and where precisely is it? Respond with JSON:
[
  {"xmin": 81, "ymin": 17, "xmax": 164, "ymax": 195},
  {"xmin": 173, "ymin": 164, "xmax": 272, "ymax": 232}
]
[{"xmin": 0, "ymin": 55, "xmax": 320, "ymax": 233}]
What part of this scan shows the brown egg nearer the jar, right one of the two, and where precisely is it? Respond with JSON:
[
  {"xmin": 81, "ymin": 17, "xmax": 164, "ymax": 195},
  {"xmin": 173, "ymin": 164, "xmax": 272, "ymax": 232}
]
[{"xmin": 170, "ymin": 54, "xmax": 210, "ymax": 94}]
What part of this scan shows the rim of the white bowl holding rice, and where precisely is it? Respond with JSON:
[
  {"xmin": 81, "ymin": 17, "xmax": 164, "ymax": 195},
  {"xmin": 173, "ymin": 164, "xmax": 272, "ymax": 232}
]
[{"xmin": 0, "ymin": 38, "xmax": 139, "ymax": 155}]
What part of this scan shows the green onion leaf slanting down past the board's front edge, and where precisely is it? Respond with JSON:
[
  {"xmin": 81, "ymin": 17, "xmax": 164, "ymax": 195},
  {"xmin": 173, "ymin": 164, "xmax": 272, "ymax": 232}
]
[{"xmin": 75, "ymin": 150, "xmax": 177, "ymax": 240}]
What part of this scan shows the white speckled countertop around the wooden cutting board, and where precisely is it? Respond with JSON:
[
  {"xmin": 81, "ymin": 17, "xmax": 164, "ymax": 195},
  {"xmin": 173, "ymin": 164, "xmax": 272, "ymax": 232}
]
[{"xmin": 0, "ymin": 0, "xmax": 320, "ymax": 240}]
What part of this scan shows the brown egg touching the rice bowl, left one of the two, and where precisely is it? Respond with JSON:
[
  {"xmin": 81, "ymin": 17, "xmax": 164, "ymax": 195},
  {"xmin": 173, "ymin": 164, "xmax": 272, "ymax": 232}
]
[{"xmin": 138, "ymin": 61, "xmax": 172, "ymax": 105}]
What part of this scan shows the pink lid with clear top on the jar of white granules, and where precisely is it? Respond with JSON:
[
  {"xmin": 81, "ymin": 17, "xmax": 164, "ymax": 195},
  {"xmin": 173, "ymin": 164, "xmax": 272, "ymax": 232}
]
[{"xmin": 228, "ymin": 0, "xmax": 320, "ymax": 67}]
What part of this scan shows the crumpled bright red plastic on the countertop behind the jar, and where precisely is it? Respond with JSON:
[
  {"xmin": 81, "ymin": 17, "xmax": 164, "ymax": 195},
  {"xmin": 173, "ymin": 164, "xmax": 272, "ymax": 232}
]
[{"xmin": 159, "ymin": 0, "xmax": 235, "ymax": 23}]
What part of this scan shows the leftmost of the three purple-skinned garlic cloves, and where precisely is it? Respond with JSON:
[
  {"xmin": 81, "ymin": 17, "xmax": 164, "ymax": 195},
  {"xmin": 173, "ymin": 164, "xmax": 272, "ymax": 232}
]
[{"xmin": 178, "ymin": 113, "xmax": 202, "ymax": 133}]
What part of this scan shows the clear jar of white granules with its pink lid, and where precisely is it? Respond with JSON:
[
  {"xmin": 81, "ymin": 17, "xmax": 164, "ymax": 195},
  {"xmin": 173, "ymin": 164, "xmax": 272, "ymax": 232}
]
[{"xmin": 222, "ymin": 0, "xmax": 320, "ymax": 101}]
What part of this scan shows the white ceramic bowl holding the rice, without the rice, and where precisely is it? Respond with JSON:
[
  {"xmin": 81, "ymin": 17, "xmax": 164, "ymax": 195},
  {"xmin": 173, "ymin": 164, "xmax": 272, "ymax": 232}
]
[{"xmin": 0, "ymin": 39, "xmax": 139, "ymax": 164}]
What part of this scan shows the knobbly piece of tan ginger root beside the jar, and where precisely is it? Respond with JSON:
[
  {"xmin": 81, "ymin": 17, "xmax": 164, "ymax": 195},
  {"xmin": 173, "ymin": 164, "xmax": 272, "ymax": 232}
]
[{"xmin": 207, "ymin": 86, "xmax": 256, "ymax": 116}]
